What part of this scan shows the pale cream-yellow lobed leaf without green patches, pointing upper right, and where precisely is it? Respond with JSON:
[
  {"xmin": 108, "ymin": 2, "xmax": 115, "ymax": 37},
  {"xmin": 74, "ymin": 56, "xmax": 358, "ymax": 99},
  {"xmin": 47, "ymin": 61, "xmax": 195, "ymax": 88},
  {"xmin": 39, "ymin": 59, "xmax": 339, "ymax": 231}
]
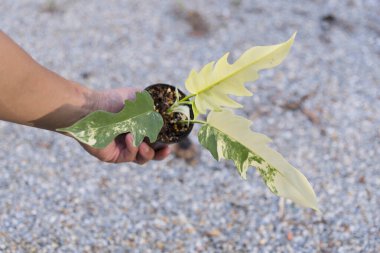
[{"xmin": 186, "ymin": 33, "xmax": 296, "ymax": 114}]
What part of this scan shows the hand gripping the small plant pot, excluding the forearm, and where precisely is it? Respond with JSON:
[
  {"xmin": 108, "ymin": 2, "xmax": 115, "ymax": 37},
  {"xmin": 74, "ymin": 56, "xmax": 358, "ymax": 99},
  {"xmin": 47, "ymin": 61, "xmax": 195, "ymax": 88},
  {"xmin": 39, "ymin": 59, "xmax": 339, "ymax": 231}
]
[{"xmin": 81, "ymin": 88, "xmax": 170, "ymax": 164}]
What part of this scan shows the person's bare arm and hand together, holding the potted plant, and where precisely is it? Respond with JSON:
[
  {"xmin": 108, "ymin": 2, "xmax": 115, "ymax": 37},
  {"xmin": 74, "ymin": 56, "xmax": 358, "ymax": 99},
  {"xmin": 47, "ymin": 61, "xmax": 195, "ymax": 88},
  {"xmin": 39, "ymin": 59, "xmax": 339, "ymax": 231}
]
[{"xmin": 0, "ymin": 30, "xmax": 170, "ymax": 164}]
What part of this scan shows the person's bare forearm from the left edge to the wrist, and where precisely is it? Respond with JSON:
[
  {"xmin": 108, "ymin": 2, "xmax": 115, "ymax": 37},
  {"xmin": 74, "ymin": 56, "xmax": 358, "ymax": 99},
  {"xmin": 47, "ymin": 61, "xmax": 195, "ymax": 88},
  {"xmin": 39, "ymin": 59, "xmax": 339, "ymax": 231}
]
[{"xmin": 0, "ymin": 31, "xmax": 100, "ymax": 130}]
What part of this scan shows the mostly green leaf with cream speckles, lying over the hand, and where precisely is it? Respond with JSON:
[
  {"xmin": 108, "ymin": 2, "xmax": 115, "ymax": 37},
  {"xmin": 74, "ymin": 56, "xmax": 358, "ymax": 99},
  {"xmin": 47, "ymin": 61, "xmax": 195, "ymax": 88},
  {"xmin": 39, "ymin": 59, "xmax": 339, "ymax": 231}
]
[{"xmin": 57, "ymin": 91, "xmax": 163, "ymax": 148}]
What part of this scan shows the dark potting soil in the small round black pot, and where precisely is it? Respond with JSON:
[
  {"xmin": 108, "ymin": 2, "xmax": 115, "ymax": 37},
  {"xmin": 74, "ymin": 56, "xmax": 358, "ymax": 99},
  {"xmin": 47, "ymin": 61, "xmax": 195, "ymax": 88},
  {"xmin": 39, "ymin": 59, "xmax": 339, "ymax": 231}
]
[{"xmin": 145, "ymin": 84, "xmax": 194, "ymax": 143}]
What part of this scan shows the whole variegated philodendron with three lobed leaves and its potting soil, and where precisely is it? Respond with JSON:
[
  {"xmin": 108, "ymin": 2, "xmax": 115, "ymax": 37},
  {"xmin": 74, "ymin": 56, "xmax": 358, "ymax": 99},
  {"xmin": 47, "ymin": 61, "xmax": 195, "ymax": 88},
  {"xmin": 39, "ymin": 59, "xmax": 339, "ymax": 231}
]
[{"xmin": 58, "ymin": 34, "xmax": 318, "ymax": 210}]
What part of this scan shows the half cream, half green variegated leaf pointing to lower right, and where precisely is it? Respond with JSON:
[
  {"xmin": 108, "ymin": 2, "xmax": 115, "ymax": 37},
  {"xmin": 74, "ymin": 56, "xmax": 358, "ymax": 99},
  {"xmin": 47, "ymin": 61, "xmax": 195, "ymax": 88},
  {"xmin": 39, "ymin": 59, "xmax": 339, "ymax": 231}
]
[{"xmin": 198, "ymin": 110, "xmax": 318, "ymax": 210}]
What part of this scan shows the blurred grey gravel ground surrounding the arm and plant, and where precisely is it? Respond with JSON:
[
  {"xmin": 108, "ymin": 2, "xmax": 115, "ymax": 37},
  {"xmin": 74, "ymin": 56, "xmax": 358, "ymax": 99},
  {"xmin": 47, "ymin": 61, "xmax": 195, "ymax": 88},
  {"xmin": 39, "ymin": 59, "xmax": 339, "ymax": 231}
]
[{"xmin": 0, "ymin": 0, "xmax": 380, "ymax": 253}]
